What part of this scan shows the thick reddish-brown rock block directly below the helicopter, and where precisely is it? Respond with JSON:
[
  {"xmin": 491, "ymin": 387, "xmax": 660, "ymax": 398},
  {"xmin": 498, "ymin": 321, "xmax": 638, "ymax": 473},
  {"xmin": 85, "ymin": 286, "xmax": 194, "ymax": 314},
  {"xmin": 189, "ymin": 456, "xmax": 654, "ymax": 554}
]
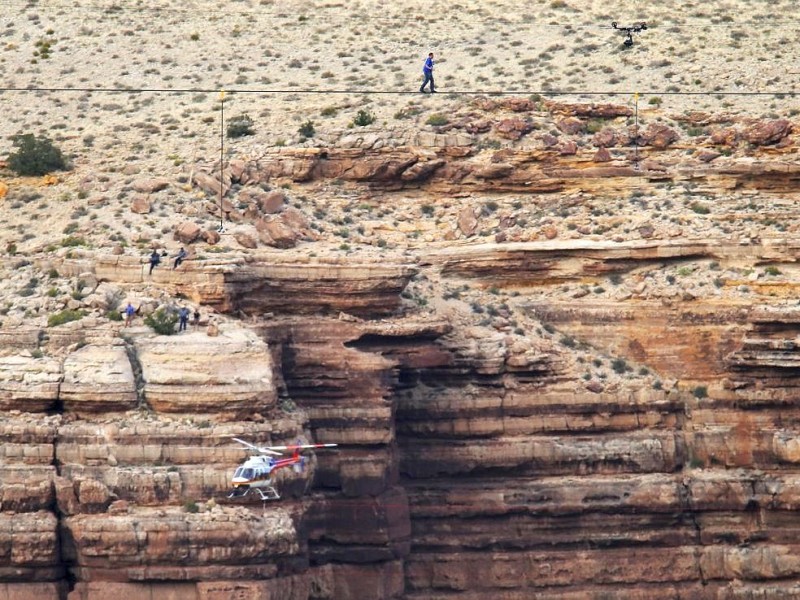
[{"xmin": 65, "ymin": 507, "xmax": 299, "ymax": 581}]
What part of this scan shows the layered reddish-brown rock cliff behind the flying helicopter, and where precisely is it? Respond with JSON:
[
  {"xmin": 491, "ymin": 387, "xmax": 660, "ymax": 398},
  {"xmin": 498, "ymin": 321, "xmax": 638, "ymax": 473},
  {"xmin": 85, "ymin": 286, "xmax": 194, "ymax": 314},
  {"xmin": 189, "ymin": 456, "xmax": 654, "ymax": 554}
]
[{"xmin": 0, "ymin": 99, "xmax": 800, "ymax": 600}]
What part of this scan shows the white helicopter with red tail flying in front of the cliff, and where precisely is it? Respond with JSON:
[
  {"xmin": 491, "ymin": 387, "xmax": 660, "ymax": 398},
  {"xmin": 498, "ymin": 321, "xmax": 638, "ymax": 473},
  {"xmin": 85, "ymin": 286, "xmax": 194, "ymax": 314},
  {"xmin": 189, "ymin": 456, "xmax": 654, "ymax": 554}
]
[{"xmin": 228, "ymin": 438, "xmax": 338, "ymax": 500}]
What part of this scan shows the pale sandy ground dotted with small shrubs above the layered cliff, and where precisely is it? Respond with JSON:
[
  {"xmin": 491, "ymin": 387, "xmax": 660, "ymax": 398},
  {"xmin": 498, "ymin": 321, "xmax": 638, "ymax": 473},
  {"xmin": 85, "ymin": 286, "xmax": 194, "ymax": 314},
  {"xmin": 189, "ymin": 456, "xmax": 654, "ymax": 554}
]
[{"xmin": 0, "ymin": 0, "xmax": 800, "ymax": 346}]
